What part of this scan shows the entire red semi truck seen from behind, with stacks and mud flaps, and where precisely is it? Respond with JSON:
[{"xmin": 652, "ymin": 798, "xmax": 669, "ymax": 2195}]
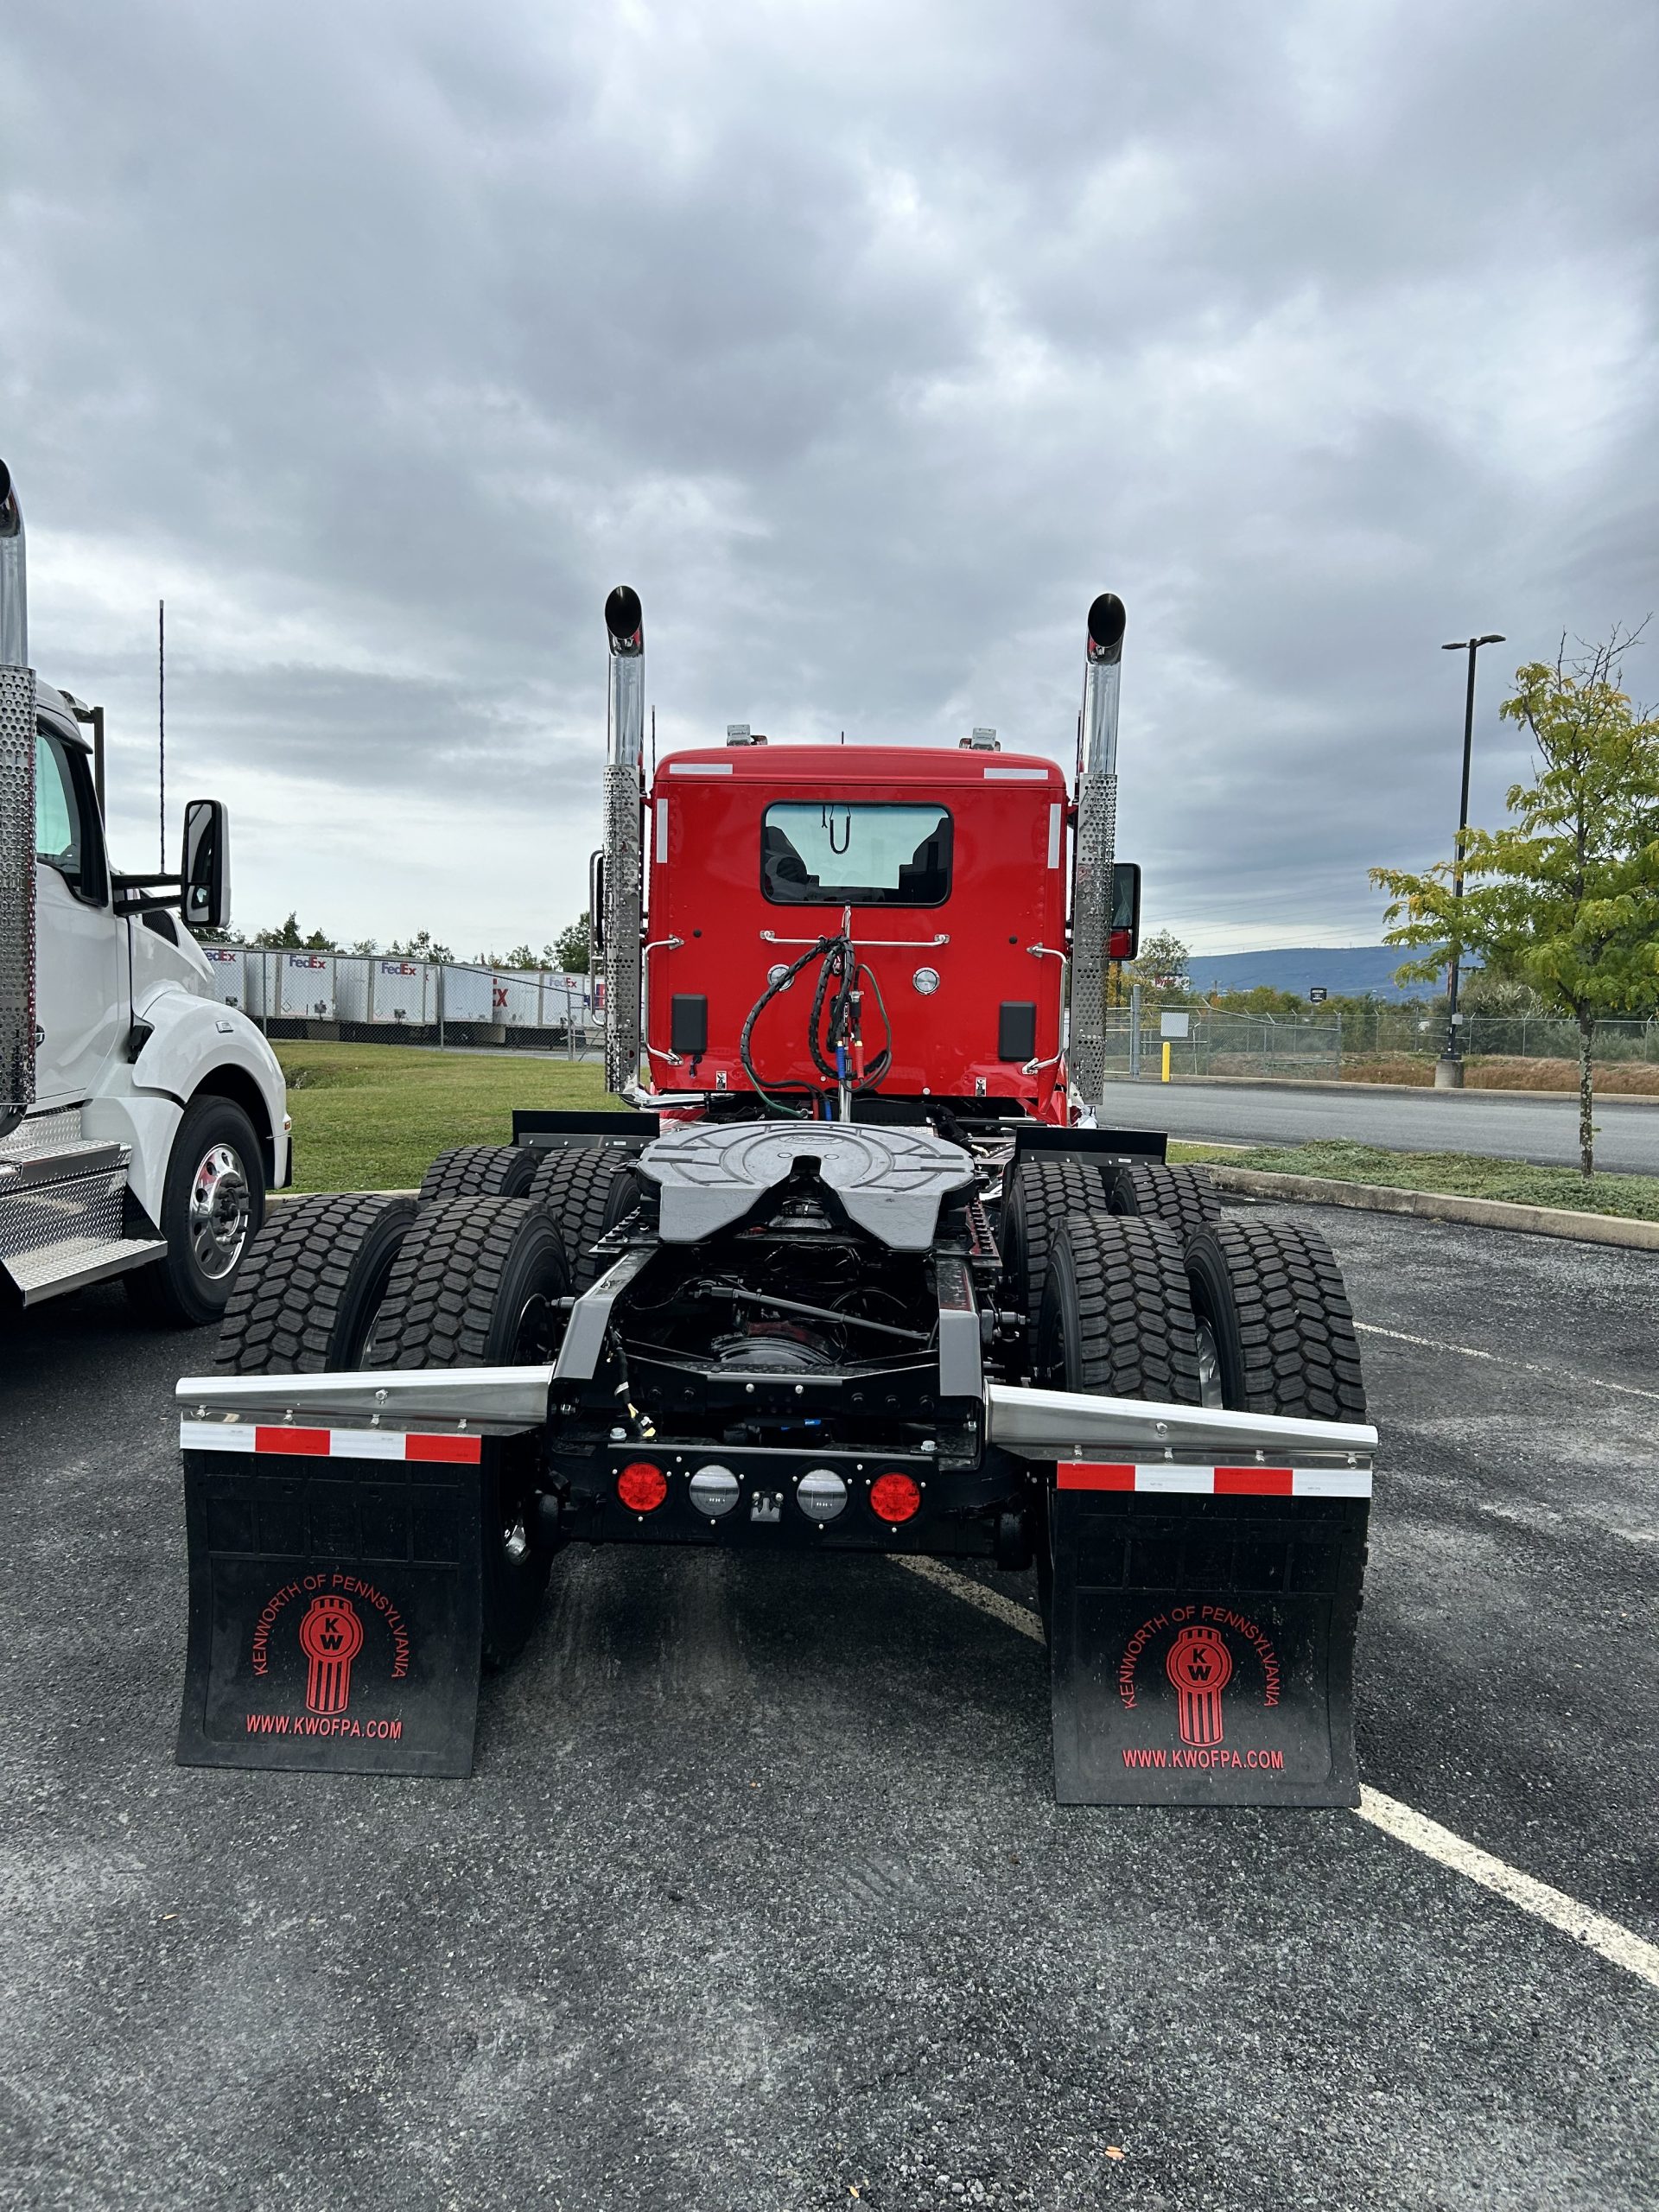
[{"xmin": 177, "ymin": 586, "xmax": 1376, "ymax": 1805}]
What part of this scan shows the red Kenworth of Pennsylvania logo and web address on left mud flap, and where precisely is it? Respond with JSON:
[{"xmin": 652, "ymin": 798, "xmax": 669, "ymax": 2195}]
[{"xmin": 248, "ymin": 1573, "xmax": 411, "ymax": 1743}]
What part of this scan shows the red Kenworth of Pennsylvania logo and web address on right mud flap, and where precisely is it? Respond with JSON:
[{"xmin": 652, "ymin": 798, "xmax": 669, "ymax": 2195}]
[{"xmin": 1117, "ymin": 1606, "xmax": 1285, "ymax": 1774}]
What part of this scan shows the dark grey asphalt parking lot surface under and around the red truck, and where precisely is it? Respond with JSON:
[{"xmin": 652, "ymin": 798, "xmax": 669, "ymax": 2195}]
[{"xmin": 0, "ymin": 1212, "xmax": 1659, "ymax": 2212}]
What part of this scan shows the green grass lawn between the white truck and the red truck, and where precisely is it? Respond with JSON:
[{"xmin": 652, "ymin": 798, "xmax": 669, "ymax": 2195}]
[{"xmin": 272, "ymin": 1039, "xmax": 617, "ymax": 1190}]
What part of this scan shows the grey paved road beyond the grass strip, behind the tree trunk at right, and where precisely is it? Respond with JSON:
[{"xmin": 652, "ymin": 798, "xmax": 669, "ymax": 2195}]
[{"xmin": 1102, "ymin": 1082, "xmax": 1659, "ymax": 1174}]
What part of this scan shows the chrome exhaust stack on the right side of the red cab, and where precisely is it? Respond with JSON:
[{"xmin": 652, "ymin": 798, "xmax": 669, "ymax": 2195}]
[{"xmin": 1066, "ymin": 591, "xmax": 1128, "ymax": 1109}]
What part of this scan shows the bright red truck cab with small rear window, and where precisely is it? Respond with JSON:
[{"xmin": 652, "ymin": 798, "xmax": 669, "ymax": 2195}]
[{"xmin": 646, "ymin": 732, "xmax": 1066, "ymax": 1119}]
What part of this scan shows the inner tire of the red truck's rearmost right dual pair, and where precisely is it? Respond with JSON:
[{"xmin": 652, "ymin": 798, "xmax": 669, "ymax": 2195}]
[{"xmin": 1033, "ymin": 1214, "xmax": 1201, "ymax": 1635}]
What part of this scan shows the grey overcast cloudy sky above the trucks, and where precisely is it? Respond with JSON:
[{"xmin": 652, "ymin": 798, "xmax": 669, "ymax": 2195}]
[{"xmin": 0, "ymin": 0, "xmax": 1659, "ymax": 953}]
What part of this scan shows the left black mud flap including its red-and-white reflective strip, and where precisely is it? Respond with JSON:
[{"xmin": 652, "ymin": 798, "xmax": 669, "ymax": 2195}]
[{"xmin": 177, "ymin": 1429, "xmax": 480, "ymax": 1774}]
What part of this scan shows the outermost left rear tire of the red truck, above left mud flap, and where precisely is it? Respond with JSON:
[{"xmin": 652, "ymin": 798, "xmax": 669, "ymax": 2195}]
[{"xmin": 213, "ymin": 1192, "xmax": 416, "ymax": 1376}]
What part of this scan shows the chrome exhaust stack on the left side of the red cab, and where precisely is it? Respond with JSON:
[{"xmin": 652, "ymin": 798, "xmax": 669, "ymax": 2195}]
[{"xmin": 595, "ymin": 584, "xmax": 646, "ymax": 1097}]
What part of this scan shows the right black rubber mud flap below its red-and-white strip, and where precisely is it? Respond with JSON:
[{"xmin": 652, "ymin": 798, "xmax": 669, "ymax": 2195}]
[{"xmin": 1048, "ymin": 1469, "xmax": 1370, "ymax": 1805}]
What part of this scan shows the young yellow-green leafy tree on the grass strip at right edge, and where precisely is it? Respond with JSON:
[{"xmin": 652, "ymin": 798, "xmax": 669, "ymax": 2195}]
[{"xmin": 1371, "ymin": 628, "xmax": 1659, "ymax": 1177}]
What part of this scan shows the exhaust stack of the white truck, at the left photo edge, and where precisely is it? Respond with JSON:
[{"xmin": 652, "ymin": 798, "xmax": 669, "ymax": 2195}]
[{"xmin": 0, "ymin": 460, "xmax": 35, "ymax": 1137}]
